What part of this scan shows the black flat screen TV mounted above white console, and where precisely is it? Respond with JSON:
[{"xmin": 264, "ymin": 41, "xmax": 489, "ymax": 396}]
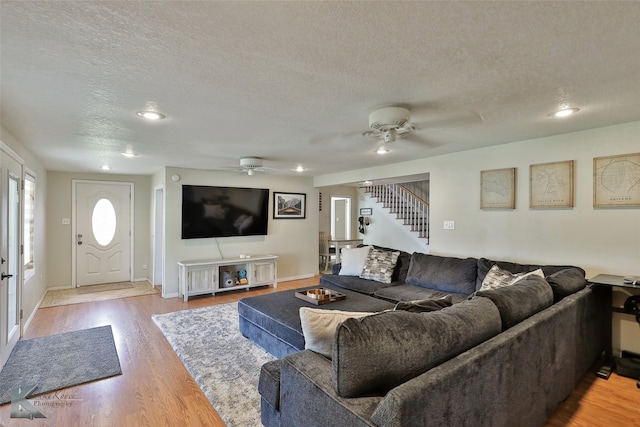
[{"xmin": 182, "ymin": 185, "xmax": 269, "ymax": 239}]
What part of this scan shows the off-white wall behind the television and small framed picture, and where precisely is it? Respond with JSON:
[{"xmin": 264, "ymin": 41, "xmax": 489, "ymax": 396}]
[{"xmin": 161, "ymin": 168, "xmax": 319, "ymax": 297}]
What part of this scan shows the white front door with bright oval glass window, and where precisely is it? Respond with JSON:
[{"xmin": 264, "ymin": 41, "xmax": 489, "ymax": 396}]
[{"xmin": 74, "ymin": 181, "xmax": 132, "ymax": 286}]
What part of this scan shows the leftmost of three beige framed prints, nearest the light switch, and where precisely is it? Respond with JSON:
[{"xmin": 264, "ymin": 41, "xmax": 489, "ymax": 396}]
[{"xmin": 480, "ymin": 168, "xmax": 516, "ymax": 209}]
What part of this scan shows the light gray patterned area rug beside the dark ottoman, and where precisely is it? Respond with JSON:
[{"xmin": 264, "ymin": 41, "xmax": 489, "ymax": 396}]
[{"xmin": 152, "ymin": 303, "xmax": 275, "ymax": 427}]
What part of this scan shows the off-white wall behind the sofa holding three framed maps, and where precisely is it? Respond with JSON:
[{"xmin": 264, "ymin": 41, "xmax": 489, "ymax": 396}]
[{"xmin": 314, "ymin": 122, "xmax": 640, "ymax": 277}]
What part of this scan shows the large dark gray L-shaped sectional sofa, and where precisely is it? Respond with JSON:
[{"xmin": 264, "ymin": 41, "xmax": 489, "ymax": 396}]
[{"xmin": 259, "ymin": 247, "xmax": 611, "ymax": 427}]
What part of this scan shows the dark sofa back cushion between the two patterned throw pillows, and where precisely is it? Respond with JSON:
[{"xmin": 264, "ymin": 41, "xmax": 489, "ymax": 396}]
[{"xmin": 407, "ymin": 252, "xmax": 478, "ymax": 295}]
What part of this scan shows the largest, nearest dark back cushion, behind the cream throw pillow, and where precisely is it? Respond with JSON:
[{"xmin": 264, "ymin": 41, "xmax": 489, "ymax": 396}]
[{"xmin": 332, "ymin": 297, "xmax": 501, "ymax": 397}]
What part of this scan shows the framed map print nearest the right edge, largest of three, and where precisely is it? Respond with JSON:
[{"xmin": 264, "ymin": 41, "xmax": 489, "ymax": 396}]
[{"xmin": 593, "ymin": 153, "xmax": 640, "ymax": 208}]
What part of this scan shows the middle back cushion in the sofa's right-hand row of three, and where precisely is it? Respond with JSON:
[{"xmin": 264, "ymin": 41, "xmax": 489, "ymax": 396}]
[{"xmin": 476, "ymin": 274, "xmax": 553, "ymax": 331}]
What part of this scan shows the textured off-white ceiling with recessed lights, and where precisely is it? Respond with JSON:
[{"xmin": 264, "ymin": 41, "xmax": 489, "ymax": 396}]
[{"xmin": 0, "ymin": 0, "xmax": 640, "ymax": 175}]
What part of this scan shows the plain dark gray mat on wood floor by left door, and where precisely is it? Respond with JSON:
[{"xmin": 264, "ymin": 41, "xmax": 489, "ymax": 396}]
[{"xmin": 0, "ymin": 325, "xmax": 122, "ymax": 404}]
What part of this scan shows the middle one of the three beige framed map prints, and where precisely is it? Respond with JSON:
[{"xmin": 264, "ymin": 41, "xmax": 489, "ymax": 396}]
[{"xmin": 529, "ymin": 160, "xmax": 574, "ymax": 209}]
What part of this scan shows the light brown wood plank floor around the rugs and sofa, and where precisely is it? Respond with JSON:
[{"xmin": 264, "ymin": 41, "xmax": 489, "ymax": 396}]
[{"xmin": 0, "ymin": 277, "xmax": 640, "ymax": 427}]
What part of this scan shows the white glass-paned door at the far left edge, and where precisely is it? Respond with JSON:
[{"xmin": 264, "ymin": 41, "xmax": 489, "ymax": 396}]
[{"xmin": 0, "ymin": 150, "xmax": 22, "ymax": 365}]
